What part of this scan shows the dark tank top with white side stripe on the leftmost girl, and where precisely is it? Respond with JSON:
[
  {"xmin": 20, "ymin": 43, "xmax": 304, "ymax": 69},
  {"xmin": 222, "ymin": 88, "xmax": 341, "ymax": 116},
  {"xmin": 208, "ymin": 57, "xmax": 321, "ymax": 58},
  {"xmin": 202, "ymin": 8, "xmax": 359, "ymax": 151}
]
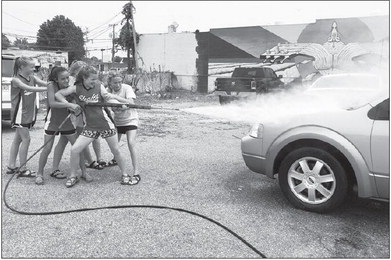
[{"xmin": 11, "ymin": 74, "xmax": 38, "ymax": 125}]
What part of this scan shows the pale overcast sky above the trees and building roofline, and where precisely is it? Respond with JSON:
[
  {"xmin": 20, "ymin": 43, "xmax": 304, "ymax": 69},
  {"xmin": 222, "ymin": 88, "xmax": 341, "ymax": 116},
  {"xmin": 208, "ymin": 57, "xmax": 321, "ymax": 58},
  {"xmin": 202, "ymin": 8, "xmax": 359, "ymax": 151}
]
[{"xmin": 1, "ymin": 1, "xmax": 389, "ymax": 60}]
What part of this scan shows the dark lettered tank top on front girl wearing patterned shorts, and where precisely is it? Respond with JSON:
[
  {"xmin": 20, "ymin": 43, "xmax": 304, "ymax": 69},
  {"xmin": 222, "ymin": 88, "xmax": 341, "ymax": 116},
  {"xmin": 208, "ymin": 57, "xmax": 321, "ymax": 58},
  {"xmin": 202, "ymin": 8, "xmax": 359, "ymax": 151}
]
[{"xmin": 75, "ymin": 83, "xmax": 115, "ymax": 131}]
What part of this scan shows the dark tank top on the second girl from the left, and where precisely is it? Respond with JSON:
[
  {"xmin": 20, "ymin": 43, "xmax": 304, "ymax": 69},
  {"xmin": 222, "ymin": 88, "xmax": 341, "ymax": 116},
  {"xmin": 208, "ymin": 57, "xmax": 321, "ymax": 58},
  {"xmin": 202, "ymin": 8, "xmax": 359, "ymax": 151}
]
[{"xmin": 44, "ymin": 82, "xmax": 75, "ymax": 131}]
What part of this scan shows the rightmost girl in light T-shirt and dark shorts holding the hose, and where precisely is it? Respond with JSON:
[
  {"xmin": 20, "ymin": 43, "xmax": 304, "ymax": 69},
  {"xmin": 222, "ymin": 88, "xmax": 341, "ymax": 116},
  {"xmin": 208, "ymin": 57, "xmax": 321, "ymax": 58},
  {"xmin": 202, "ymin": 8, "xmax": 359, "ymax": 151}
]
[{"xmin": 107, "ymin": 73, "xmax": 140, "ymax": 180}]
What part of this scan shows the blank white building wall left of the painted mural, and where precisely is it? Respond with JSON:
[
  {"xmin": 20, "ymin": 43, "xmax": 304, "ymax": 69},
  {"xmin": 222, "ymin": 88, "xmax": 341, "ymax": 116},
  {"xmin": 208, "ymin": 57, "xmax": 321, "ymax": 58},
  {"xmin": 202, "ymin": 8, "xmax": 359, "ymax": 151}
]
[{"xmin": 138, "ymin": 33, "xmax": 198, "ymax": 91}]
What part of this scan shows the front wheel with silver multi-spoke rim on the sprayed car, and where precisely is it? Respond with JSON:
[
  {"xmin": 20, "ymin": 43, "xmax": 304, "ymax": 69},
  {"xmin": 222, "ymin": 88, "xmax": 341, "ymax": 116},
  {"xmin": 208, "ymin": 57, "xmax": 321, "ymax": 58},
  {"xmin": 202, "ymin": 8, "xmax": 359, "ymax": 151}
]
[{"xmin": 278, "ymin": 147, "xmax": 349, "ymax": 213}]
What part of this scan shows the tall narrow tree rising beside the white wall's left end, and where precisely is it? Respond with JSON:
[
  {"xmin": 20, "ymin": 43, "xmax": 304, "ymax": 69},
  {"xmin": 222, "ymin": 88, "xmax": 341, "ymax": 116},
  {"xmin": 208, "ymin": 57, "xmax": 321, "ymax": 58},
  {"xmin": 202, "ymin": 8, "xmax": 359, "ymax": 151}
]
[{"xmin": 115, "ymin": 3, "xmax": 140, "ymax": 73}]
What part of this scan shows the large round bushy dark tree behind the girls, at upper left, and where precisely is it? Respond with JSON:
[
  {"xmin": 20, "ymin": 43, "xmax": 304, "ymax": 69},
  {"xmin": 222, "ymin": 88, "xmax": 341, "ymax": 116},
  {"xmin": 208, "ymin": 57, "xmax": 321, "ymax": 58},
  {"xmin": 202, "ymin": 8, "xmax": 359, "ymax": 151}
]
[{"xmin": 37, "ymin": 15, "xmax": 86, "ymax": 63}]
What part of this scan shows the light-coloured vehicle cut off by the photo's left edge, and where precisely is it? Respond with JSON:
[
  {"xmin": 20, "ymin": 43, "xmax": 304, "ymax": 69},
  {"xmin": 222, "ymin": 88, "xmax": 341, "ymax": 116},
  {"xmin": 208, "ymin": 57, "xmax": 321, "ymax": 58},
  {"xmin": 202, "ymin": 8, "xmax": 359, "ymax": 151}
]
[{"xmin": 1, "ymin": 55, "xmax": 16, "ymax": 120}]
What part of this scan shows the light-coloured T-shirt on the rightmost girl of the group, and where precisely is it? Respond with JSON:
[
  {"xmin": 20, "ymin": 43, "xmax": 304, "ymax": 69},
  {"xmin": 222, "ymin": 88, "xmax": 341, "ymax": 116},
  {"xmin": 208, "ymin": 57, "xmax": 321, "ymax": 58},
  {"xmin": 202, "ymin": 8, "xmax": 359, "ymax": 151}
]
[{"xmin": 108, "ymin": 84, "xmax": 138, "ymax": 126}]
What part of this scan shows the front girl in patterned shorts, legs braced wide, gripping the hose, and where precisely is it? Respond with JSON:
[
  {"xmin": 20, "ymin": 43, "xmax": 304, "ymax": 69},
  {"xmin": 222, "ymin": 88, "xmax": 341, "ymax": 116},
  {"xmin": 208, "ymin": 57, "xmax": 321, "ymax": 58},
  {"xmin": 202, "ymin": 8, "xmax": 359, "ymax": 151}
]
[{"xmin": 55, "ymin": 66, "xmax": 139, "ymax": 187}]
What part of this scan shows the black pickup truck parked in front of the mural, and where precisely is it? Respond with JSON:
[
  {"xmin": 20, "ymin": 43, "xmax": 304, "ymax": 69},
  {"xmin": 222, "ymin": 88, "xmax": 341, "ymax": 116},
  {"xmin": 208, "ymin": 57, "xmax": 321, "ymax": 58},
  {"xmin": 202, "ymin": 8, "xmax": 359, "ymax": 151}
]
[{"xmin": 214, "ymin": 67, "xmax": 284, "ymax": 105}]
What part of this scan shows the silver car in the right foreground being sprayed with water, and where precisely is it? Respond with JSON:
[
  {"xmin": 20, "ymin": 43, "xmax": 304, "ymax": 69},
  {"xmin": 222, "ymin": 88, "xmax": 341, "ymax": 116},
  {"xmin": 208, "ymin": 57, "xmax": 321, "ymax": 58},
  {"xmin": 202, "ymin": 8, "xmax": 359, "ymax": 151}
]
[{"xmin": 241, "ymin": 74, "xmax": 390, "ymax": 212}]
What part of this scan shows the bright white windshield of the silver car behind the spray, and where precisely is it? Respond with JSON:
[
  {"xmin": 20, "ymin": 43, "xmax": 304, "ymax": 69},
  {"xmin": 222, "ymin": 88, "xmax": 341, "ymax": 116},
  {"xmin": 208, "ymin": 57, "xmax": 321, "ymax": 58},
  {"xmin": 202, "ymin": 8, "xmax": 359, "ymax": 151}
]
[{"xmin": 308, "ymin": 74, "xmax": 388, "ymax": 110}]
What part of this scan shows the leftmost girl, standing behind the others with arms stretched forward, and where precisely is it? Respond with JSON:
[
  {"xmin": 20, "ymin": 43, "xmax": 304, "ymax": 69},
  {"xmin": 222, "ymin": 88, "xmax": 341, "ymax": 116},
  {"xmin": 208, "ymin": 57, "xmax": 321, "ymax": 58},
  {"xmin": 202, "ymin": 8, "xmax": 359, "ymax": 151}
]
[{"xmin": 7, "ymin": 56, "xmax": 47, "ymax": 177}]
